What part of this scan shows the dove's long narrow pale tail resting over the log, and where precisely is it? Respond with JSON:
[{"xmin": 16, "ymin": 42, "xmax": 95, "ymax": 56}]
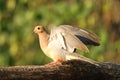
[{"xmin": 66, "ymin": 53, "xmax": 99, "ymax": 66}]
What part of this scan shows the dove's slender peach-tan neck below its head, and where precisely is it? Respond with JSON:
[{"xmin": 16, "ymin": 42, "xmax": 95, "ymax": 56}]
[{"xmin": 39, "ymin": 32, "xmax": 49, "ymax": 51}]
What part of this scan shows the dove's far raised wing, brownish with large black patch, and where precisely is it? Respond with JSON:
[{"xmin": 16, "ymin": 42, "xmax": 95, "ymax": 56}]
[{"xmin": 58, "ymin": 25, "xmax": 100, "ymax": 46}]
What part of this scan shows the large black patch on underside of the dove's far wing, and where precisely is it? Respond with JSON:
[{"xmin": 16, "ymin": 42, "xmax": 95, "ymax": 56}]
[{"xmin": 75, "ymin": 35, "xmax": 100, "ymax": 46}]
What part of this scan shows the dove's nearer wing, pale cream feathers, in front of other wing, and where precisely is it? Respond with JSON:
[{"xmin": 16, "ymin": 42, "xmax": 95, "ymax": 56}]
[{"xmin": 49, "ymin": 27, "xmax": 89, "ymax": 53}]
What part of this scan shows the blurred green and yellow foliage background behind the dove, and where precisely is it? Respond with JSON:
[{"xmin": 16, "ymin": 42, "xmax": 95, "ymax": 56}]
[{"xmin": 0, "ymin": 0, "xmax": 120, "ymax": 66}]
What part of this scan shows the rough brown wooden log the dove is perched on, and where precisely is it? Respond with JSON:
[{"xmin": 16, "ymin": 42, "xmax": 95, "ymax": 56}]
[{"xmin": 0, "ymin": 60, "xmax": 120, "ymax": 80}]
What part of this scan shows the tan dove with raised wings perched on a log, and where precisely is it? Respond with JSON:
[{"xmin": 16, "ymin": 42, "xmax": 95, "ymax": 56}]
[{"xmin": 33, "ymin": 25, "xmax": 100, "ymax": 65}]
